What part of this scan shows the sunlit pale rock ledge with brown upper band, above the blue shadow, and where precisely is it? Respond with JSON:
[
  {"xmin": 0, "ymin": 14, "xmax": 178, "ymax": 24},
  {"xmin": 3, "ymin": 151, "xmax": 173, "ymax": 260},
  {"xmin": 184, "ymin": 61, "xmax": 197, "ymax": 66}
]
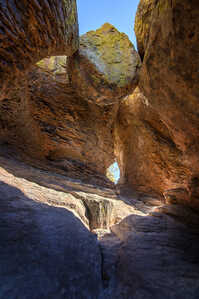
[{"xmin": 0, "ymin": 146, "xmax": 138, "ymax": 230}]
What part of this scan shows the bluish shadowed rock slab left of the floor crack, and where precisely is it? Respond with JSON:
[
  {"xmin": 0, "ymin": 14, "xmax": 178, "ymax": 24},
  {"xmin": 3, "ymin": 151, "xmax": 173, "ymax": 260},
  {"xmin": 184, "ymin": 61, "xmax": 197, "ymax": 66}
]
[{"xmin": 0, "ymin": 182, "xmax": 101, "ymax": 299}]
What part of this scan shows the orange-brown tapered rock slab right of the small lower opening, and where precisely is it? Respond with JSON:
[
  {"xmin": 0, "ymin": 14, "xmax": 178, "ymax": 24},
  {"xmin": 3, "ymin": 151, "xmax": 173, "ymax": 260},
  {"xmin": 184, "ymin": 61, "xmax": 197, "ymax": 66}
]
[{"xmin": 114, "ymin": 88, "xmax": 189, "ymax": 196}]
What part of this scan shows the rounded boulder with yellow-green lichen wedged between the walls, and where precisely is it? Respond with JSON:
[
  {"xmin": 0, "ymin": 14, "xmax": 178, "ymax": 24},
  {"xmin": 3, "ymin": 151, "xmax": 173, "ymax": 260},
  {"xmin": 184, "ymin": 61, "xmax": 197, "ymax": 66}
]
[{"xmin": 68, "ymin": 23, "xmax": 141, "ymax": 105}]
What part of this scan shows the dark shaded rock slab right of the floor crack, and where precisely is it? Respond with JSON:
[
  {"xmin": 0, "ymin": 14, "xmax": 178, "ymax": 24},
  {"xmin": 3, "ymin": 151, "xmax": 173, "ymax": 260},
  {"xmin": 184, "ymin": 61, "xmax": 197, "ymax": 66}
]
[{"xmin": 110, "ymin": 206, "xmax": 199, "ymax": 299}]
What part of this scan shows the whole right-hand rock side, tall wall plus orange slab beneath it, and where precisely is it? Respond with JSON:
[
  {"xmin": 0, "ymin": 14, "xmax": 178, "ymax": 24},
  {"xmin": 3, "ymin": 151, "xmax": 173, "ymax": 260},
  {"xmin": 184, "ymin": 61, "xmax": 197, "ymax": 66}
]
[{"xmin": 116, "ymin": 0, "xmax": 199, "ymax": 208}]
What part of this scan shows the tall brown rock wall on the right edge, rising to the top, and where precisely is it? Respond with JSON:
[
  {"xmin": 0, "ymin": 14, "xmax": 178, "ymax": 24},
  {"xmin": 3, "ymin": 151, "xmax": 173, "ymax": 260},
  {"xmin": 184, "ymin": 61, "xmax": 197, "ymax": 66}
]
[{"xmin": 132, "ymin": 0, "xmax": 199, "ymax": 206}]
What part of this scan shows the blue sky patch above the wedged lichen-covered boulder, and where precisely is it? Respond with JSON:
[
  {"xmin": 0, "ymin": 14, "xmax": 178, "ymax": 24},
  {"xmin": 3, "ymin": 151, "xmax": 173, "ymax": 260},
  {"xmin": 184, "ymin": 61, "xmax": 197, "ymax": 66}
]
[{"xmin": 77, "ymin": 0, "xmax": 139, "ymax": 45}]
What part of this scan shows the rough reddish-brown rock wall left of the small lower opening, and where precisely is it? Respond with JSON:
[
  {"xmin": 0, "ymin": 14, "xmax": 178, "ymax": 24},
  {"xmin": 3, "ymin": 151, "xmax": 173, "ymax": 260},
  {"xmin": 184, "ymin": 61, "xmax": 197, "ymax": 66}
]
[{"xmin": 0, "ymin": 62, "xmax": 118, "ymax": 186}]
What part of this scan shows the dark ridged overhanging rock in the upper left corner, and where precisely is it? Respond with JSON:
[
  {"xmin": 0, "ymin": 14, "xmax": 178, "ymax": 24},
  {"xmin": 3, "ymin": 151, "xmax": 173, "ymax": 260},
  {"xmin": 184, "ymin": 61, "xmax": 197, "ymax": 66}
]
[{"xmin": 0, "ymin": 0, "xmax": 79, "ymax": 99}]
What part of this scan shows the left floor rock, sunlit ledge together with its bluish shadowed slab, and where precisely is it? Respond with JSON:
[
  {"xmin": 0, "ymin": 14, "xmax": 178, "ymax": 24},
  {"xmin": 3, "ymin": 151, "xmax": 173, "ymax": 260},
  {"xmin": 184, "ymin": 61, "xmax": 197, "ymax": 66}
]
[{"xmin": 0, "ymin": 147, "xmax": 141, "ymax": 299}]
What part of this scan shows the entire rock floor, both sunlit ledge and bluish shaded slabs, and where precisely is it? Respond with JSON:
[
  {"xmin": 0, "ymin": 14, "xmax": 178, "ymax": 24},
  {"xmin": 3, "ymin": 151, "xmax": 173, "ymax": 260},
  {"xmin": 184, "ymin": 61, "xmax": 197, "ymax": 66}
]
[{"xmin": 0, "ymin": 146, "xmax": 199, "ymax": 299}]
